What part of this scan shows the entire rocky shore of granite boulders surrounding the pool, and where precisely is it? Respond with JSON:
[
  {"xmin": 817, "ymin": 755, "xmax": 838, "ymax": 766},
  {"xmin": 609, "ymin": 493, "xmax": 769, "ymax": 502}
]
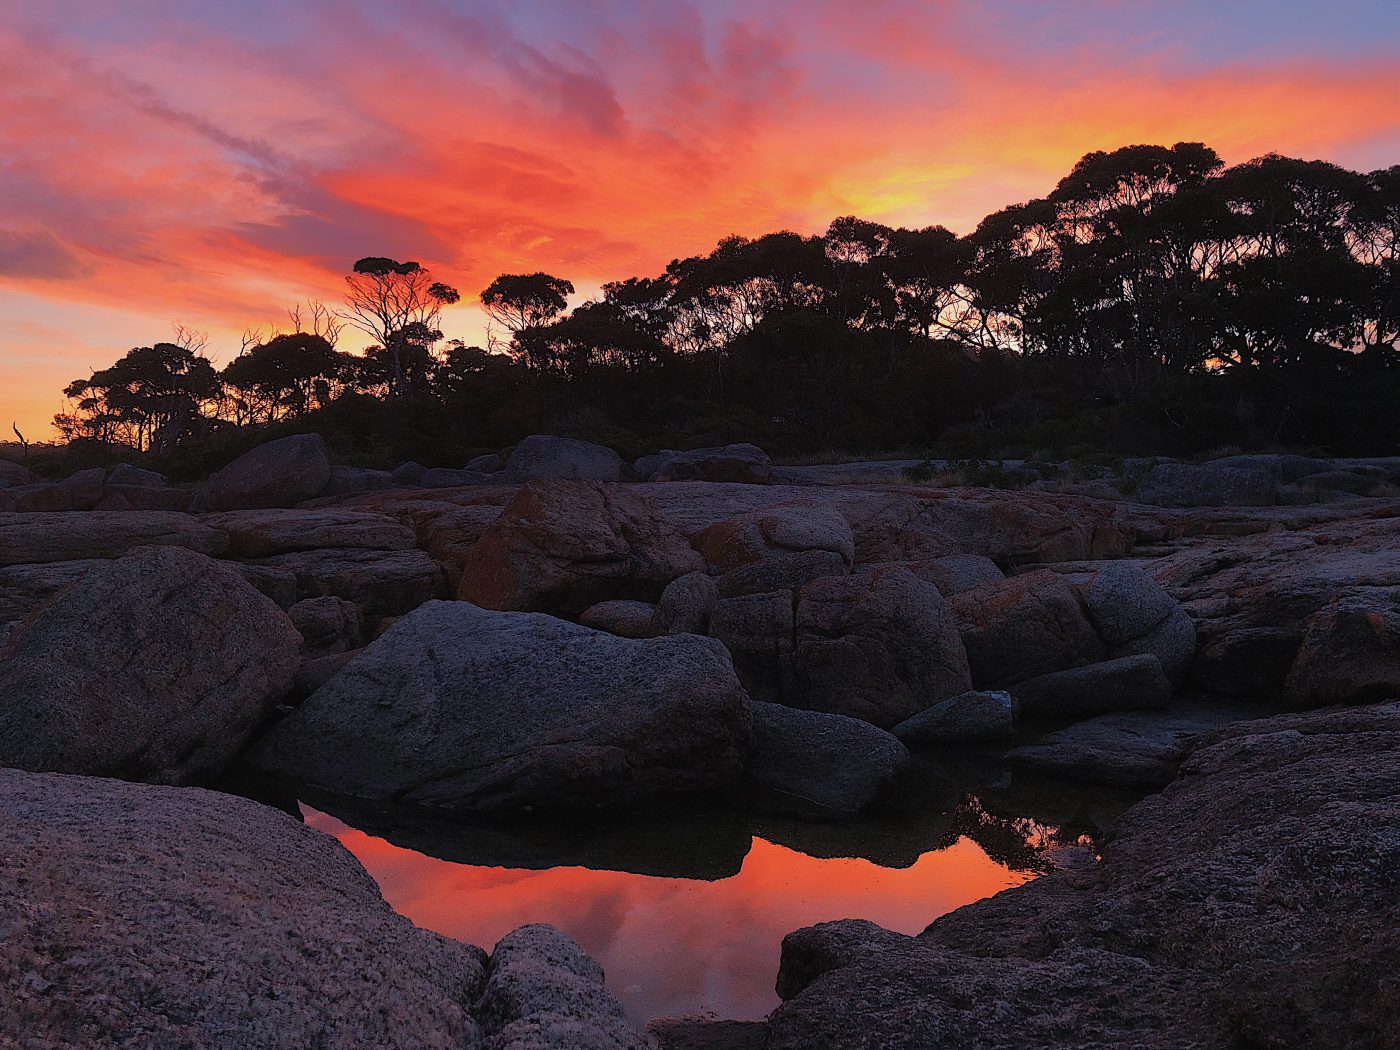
[{"xmin": 0, "ymin": 435, "xmax": 1400, "ymax": 1050}]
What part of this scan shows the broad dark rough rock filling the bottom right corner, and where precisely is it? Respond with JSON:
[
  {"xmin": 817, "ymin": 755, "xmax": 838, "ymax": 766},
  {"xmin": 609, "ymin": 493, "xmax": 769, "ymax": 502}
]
[{"xmin": 766, "ymin": 704, "xmax": 1400, "ymax": 1050}]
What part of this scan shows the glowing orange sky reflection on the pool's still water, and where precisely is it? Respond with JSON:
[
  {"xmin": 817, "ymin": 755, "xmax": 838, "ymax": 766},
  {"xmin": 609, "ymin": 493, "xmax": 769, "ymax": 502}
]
[{"xmin": 304, "ymin": 808, "xmax": 1030, "ymax": 1022}]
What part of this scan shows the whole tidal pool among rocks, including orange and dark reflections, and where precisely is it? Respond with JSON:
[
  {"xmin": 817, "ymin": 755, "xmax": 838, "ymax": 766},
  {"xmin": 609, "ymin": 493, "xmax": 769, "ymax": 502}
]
[{"xmin": 301, "ymin": 799, "xmax": 1080, "ymax": 1023}]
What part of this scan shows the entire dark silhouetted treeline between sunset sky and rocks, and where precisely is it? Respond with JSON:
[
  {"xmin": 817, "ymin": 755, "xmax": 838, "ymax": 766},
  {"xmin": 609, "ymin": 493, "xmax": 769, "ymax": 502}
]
[{"xmin": 43, "ymin": 143, "xmax": 1400, "ymax": 473}]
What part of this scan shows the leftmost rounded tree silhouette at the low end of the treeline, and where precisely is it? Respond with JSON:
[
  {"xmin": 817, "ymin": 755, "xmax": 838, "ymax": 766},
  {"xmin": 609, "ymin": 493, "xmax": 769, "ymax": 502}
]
[{"xmin": 53, "ymin": 343, "xmax": 218, "ymax": 452}]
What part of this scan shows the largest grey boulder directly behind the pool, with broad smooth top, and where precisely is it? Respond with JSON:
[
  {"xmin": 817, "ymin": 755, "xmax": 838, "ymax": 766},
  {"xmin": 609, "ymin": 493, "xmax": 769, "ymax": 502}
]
[{"xmin": 252, "ymin": 602, "xmax": 750, "ymax": 812}]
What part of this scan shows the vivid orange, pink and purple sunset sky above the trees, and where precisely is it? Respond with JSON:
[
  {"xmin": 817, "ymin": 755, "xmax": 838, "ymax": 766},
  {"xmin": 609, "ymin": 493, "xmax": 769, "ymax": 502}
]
[{"xmin": 0, "ymin": 0, "xmax": 1400, "ymax": 440}]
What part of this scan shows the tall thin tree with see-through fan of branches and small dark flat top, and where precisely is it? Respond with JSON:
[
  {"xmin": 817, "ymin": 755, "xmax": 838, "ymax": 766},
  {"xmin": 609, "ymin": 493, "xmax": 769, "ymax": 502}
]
[{"xmin": 343, "ymin": 256, "xmax": 461, "ymax": 398}]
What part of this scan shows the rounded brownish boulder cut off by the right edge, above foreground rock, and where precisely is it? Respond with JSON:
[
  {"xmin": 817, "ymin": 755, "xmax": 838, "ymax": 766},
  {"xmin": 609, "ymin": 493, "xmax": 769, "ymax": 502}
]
[{"xmin": 1284, "ymin": 587, "xmax": 1400, "ymax": 707}]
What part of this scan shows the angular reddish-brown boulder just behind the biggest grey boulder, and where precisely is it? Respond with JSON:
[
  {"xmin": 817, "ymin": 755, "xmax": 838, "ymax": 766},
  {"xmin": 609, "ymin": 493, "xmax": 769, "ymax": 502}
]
[{"xmin": 458, "ymin": 482, "xmax": 703, "ymax": 616}]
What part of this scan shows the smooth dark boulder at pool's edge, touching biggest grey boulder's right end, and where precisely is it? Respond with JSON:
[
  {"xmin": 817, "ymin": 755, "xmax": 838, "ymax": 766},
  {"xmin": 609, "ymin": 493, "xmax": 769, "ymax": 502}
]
[{"xmin": 746, "ymin": 701, "xmax": 909, "ymax": 818}]
